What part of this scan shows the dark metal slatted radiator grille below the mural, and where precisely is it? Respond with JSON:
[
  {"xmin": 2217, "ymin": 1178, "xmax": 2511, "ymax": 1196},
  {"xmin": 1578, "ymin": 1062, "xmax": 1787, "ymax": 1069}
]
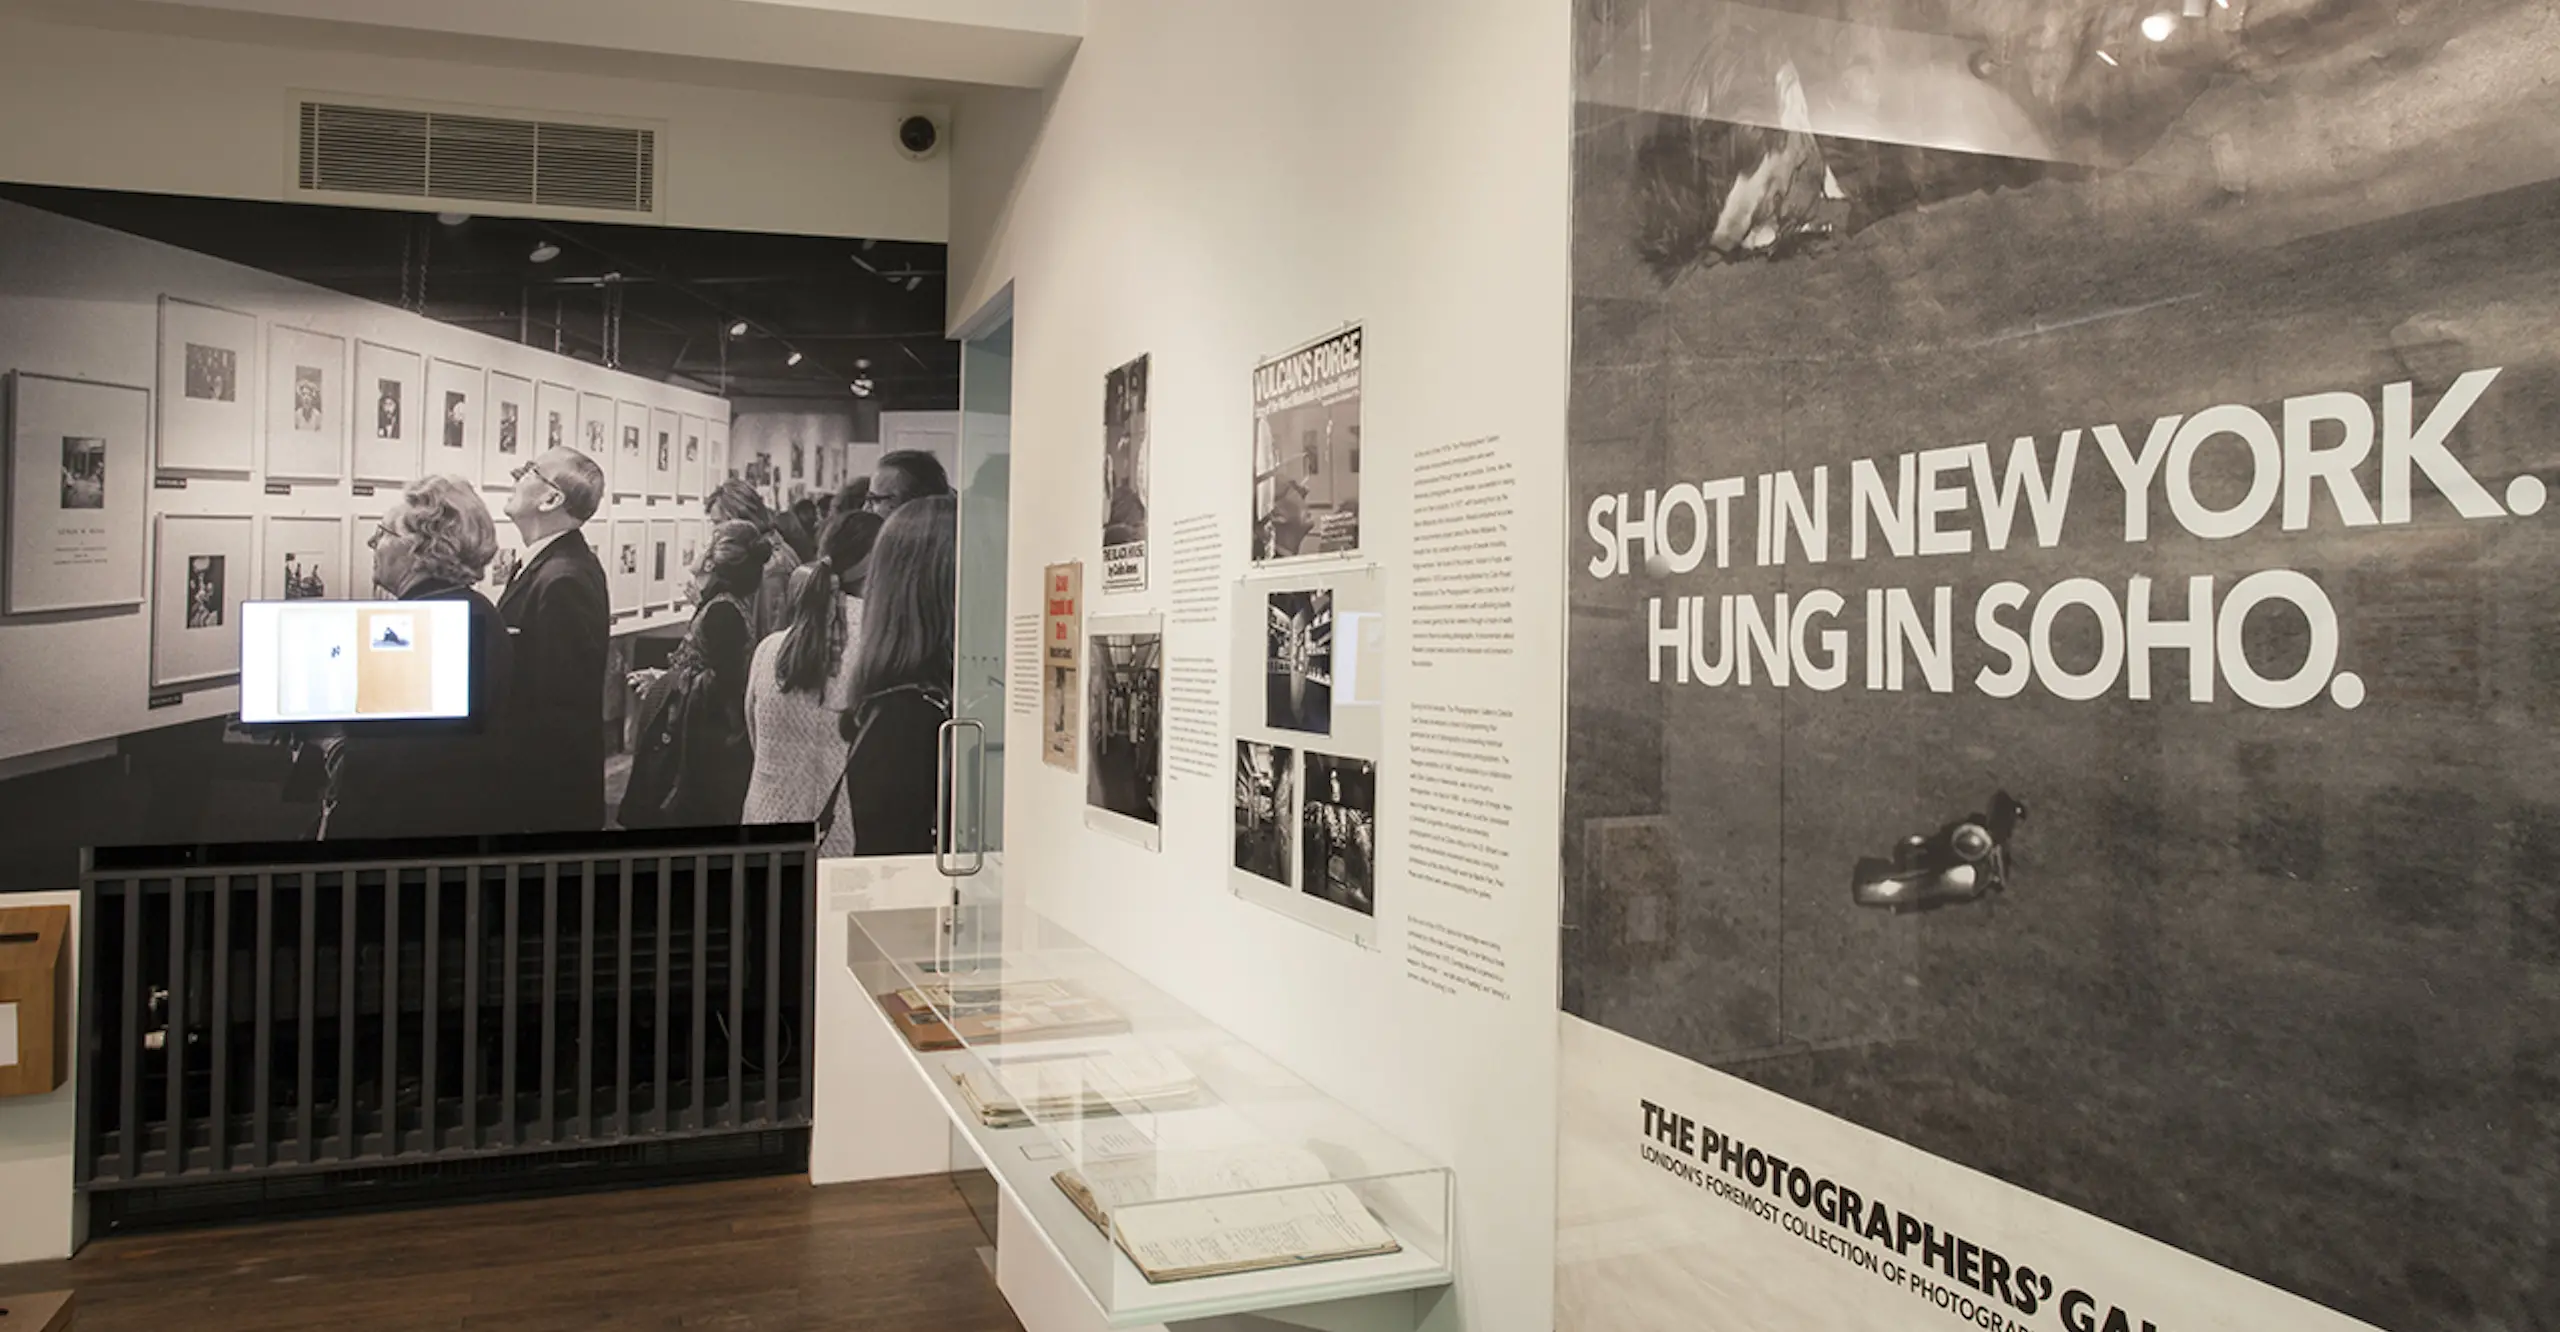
[{"xmin": 79, "ymin": 848, "xmax": 814, "ymax": 1189}]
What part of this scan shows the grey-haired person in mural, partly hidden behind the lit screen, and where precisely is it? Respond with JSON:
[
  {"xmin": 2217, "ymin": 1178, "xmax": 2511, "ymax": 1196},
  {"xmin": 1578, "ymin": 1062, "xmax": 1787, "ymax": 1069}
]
[{"xmin": 307, "ymin": 476, "xmax": 522, "ymax": 840}]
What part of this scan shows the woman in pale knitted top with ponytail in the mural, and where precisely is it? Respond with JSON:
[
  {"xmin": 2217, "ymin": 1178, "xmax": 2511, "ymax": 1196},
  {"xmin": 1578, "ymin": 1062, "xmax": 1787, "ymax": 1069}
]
[{"xmin": 740, "ymin": 510, "xmax": 885, "ymax": 856}]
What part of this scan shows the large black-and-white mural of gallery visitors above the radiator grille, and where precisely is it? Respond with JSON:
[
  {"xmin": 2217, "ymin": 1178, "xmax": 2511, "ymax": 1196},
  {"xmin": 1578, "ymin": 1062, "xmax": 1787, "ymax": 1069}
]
[{"xmin": 0, "ymin": 182, "xmax": 960, "ymax": 891}]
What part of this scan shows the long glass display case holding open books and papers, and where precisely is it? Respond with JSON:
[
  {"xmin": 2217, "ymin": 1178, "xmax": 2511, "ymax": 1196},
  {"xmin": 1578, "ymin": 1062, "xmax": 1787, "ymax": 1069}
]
[{"xmin": 847, "ymin": 904, "xmax": 1452, "ymax": 1327}]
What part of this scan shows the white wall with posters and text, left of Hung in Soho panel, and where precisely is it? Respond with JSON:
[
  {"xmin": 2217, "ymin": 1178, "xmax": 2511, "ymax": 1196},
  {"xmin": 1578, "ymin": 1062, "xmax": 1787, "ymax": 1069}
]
[{"xmin": 952, "ymin": 0, "xmax": 1569, "ymax": 1332}]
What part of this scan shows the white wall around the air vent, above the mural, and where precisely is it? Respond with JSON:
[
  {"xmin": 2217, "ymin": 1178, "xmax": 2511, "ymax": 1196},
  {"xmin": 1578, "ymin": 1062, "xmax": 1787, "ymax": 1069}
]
[{"xmin": 0, "ymin": 0, "xmax": 950, "ymax": 241}]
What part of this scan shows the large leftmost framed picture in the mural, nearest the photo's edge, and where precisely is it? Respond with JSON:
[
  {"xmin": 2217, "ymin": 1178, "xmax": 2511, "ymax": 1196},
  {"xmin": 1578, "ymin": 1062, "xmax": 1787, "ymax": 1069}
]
[{"xmin": 5, "ymin": 371, "xmax": 151, "ymax": 615}]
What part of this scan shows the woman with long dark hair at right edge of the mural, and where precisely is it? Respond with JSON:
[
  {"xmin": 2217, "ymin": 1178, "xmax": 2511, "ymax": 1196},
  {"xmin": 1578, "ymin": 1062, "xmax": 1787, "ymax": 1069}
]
[{"xmin": 842, "ymin": 494, "xmax": 960, "ymax": 856}]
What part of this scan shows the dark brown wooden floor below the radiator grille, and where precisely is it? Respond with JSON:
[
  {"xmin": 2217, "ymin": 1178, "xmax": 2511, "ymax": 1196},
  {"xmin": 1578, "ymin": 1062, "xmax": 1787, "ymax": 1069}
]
[{"xmin": 0, "ymin": 1176, "xmax": 1021, "ymax": 1332}]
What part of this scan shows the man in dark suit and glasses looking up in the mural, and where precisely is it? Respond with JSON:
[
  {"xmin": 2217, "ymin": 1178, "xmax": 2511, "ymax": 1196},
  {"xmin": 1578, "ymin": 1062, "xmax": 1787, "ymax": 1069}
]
[{"xmin": 497, "ymin": 448, "xmax": 612, "ymax": 833}]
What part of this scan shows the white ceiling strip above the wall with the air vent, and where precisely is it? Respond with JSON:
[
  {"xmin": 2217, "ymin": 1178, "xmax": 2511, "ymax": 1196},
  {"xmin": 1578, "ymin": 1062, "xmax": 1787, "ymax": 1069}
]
[{"xmin": 0, "ymin": 0, "xmax": 1085, "ymax": 95}]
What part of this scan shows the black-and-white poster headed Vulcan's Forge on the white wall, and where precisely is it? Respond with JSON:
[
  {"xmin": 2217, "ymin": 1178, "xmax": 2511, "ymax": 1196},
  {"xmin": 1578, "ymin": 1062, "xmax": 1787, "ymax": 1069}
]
[{"xmin": 1252, "ymin": 325, "xmax": 1362, "ymax": 564}]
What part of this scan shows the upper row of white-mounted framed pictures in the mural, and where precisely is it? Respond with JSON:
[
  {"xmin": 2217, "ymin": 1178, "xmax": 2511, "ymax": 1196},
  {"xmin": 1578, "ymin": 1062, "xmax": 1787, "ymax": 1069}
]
[{"xmin": 154, "ymin": 295, "xmax": 730, "ymax": 500}]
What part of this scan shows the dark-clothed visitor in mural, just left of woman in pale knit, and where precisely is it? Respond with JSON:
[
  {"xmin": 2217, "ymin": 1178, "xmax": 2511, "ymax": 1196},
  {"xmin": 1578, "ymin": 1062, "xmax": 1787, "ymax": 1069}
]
[{"xmin": 620, "ymin": 520, "xmax": 773, "ymax": 827}]
